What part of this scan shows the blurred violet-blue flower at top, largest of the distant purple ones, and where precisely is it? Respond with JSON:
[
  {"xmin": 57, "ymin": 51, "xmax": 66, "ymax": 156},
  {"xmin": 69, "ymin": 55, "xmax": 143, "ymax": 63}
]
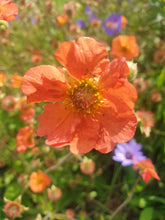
[{"xmin": 103, "ymin": 14, "xmax": 122, "ymax": 36}]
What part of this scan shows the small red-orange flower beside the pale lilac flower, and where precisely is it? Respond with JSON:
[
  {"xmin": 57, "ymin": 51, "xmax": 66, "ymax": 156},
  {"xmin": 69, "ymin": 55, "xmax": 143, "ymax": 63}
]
[{"xmin": 133, "ymin": 158, "xmax": 160, "ymax": 183}]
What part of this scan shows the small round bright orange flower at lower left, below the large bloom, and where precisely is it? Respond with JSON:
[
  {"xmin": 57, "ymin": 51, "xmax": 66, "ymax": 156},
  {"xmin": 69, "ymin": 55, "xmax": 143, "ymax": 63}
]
[{"xmin": 29, "ymin": 170, "xmax": 51, "ymax": 193}]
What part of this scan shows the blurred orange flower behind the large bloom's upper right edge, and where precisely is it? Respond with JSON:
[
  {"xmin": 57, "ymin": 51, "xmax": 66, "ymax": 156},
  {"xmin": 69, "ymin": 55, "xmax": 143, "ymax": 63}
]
[{"xmin": 111, "ymin": 35, "xmax": 139, "ymax": 60}]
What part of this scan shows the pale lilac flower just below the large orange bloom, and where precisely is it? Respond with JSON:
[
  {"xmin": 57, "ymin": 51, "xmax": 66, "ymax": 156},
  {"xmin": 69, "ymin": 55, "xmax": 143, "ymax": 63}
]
[{"xmin": 112, "ymin": 139, "xmax": 146, "ymax": 166}]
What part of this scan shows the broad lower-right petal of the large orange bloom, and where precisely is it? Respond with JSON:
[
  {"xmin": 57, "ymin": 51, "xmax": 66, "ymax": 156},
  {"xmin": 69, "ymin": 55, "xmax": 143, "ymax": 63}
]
[{"xmin": 96, "ymin": 97, "xmax": 137, "ymax": 144}]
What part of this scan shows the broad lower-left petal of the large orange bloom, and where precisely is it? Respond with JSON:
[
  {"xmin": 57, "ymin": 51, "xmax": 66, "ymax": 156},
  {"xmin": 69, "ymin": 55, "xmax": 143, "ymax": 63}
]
[{"xmin": 37, "ymin": 103, "xmax": 80, "ymax": 147}]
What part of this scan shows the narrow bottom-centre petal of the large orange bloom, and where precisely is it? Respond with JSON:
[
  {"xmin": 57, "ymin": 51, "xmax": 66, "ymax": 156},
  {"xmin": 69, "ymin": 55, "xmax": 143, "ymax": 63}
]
[{"xmin": 70, "ymin": 116, "xmax": 99, "ymax": 154}]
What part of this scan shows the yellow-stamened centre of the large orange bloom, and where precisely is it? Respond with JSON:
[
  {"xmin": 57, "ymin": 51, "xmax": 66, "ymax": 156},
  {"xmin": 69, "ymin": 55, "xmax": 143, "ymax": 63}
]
[{"xmin": 65, "ymin": 78, "xmax": 103, "ymax": 113}]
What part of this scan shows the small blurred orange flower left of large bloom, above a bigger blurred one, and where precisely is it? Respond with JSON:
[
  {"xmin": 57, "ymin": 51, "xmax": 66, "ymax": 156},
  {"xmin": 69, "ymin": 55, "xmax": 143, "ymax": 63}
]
[{"xmin": 18, "ymin": 97, "xmax": 35, "ymax": 122}]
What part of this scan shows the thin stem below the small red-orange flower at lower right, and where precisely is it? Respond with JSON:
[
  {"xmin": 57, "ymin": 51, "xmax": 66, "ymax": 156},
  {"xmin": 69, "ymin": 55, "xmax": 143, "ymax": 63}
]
[{"xmin": 109, "ymin": 175, "xmax": 141, "ymax": 220}]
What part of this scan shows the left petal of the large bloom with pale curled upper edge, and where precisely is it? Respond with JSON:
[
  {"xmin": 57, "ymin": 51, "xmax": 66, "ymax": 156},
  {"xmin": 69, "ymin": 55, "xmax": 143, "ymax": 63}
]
[{"xmin": 22, "ymin": 65, "xmax": 67, "ymax": 103}]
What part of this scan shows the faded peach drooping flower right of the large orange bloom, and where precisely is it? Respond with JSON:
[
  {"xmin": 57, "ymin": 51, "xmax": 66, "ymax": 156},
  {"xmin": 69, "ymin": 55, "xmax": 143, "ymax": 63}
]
[{"xmin": 136, "ymin": 110, "xmax": 155, "ymax": 137}]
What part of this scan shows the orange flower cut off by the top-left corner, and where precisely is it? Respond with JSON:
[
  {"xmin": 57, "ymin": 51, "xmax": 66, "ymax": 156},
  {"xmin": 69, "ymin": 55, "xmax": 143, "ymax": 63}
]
[{"xmin": 0, "ymin": 0, "xmax": 18, "ymax": 21}]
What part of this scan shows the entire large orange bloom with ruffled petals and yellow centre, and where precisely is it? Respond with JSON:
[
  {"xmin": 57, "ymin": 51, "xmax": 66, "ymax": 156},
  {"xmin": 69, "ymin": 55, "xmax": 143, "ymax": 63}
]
[{"xmin": 22, "ymin": 37, "xmax": 137, "ymax": 154}]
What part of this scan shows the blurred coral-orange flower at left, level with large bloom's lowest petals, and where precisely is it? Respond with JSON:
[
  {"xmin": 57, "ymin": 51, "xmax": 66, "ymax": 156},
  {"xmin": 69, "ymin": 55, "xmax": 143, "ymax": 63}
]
[{"xmin": 16, "ymin": 125, "xmax": 35, "ymax": 153}]
